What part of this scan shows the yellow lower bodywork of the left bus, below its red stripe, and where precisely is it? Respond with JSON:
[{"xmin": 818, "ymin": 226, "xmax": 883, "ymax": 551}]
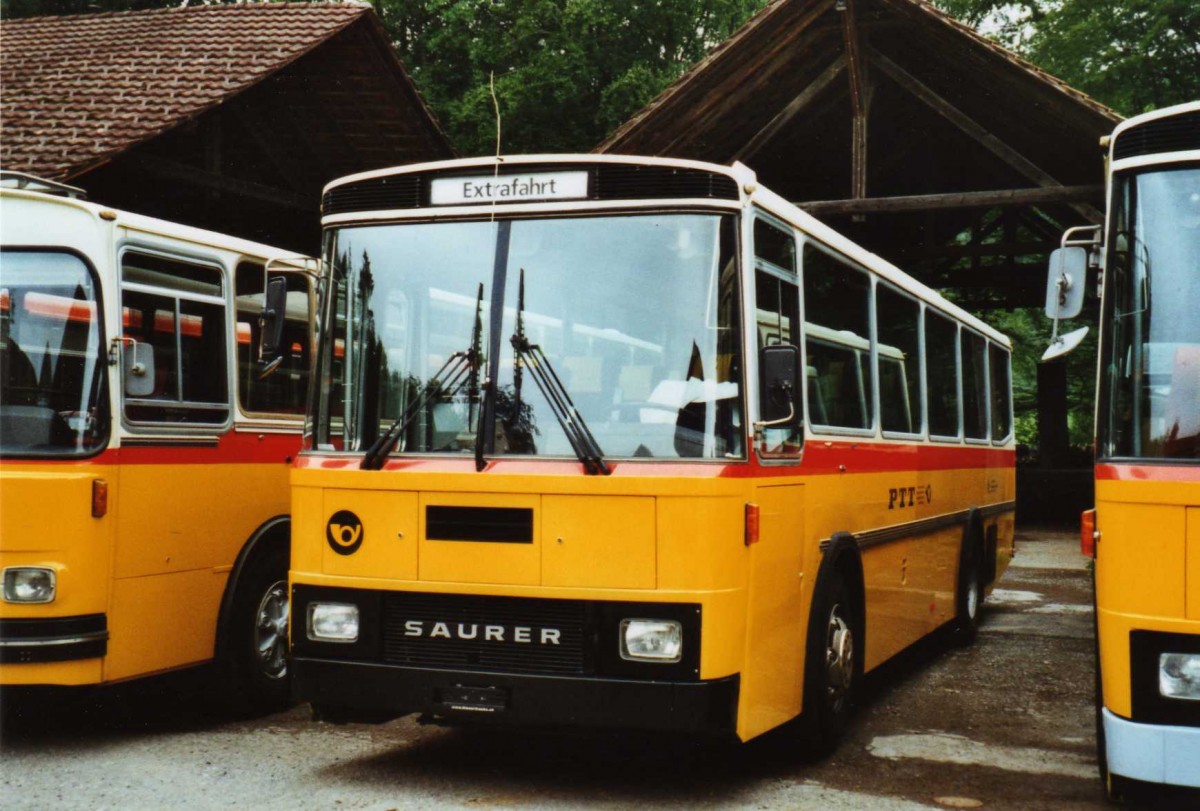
[{"xmin": 0, "ymin": 453, "xmax": 288, "ymax": 685}]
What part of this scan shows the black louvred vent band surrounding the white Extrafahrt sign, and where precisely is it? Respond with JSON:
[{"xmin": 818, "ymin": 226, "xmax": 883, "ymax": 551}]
[{"xmin": 320, "ymin": 163, "xmax": 738, "ymax": 216}]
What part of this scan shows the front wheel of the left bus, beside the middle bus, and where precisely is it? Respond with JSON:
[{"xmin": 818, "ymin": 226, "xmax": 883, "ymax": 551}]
[{"xmin": 221, "ymin": 545, "xmax": 290, "ymax": 715}]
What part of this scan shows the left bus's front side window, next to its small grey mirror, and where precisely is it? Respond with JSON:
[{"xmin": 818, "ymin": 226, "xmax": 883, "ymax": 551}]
[{"xmin": 121, "ymin": 252, "xmax": 229, "ymax": 425}]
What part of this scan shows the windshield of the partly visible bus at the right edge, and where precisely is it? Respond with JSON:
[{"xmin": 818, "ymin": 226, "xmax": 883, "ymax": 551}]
[{"xmin": 1099, "ymin": 166, "xmax": 1200, "ymax": 459}]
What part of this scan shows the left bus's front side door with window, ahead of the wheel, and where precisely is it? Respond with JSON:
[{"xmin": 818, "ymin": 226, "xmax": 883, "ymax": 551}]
[{"xmin": 104, "ymin": 251, "xmax": 237, "ymax": 680}]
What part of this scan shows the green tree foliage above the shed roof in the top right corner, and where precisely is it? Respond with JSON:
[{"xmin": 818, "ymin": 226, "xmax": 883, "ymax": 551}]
[{"xmin": 935, "ymin": 0, "xmax": 1200, "ymax": 115}]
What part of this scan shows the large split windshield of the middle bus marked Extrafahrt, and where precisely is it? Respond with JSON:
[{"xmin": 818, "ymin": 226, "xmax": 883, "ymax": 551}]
[{"xmin": 313, "ymin": 214, "xmax": 744, "ymax": 458}]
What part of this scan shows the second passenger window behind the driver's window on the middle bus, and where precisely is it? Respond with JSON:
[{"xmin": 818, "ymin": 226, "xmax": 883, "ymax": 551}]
[{"xmin": 875, "ymin": 283, "xmax": 923, "ymax": 433}]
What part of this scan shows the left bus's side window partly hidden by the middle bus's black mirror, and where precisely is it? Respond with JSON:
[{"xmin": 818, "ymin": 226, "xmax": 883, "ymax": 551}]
[{"xmin": 234, "ymin": 262, "xmax": 312, "ymax": 414}]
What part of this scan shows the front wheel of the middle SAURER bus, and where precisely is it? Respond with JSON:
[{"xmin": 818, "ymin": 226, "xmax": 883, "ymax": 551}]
[{"xmin": 797, "ymin": 572, "xmax": 863, "ymax": 758}]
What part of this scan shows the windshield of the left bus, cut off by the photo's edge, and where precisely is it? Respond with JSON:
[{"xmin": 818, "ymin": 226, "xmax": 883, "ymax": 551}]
[{"xmin": 0, "ymin": 251, "xmax": 108, "ymax": 455}]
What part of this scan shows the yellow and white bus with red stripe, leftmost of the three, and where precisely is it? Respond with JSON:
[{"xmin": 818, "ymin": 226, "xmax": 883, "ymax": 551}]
[{"xmin": 0, "ymin": 173, "xmax": 316, "ymax": 709}]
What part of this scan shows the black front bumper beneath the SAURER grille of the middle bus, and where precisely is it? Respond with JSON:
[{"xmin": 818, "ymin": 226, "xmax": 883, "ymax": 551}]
[{"xmin": 290, "ymin": 657, "xmax": 739, "ymax": 734}]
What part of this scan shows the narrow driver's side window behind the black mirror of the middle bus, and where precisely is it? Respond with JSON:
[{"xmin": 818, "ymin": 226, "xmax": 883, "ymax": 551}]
[{"xmin": 754, "ymin": 220, "xmax": 802, "ymax": 457}]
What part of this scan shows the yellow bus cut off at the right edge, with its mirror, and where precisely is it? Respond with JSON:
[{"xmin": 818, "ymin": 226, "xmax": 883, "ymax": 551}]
[{"xmin": 1048, "ymin": 102, "xmax": 1200, "ymax": 797}]
